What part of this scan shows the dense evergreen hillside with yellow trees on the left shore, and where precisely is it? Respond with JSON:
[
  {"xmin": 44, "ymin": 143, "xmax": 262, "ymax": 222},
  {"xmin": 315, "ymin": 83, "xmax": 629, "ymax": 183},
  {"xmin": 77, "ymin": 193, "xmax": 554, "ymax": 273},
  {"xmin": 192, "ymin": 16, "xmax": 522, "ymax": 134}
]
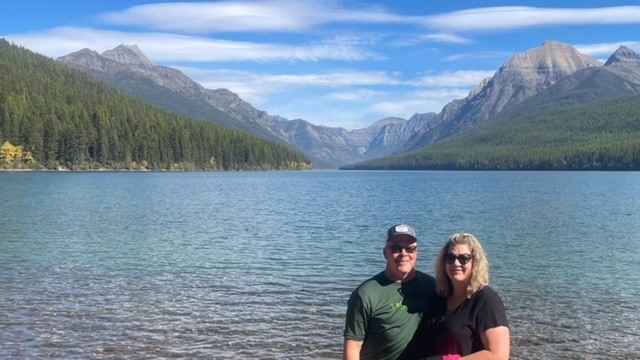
[{"xmin": 0, "ymin": 39, "xmax": 310, "ymax": 170}]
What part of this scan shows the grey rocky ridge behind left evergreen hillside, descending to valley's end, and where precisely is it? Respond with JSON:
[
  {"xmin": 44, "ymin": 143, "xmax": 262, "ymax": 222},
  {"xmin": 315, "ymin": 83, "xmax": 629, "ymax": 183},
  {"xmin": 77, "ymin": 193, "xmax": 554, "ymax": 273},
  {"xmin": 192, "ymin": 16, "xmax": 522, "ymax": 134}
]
[{"xmin": 57, "ymin": 45, "xmax": 424, "ymax": 168}]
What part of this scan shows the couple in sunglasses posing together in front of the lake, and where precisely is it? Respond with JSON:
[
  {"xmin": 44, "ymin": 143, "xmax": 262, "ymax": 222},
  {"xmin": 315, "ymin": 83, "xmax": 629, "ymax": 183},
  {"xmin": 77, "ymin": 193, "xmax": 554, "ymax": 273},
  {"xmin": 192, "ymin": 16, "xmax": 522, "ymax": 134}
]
[{"xmin": 343, "ymin": 224, "xmax": 510, "ymax": 360}]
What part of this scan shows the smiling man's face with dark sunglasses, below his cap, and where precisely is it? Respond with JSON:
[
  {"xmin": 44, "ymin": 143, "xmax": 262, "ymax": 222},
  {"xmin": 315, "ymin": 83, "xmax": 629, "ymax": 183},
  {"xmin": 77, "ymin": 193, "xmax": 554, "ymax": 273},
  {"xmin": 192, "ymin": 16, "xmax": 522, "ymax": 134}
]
[{"xmin": 384, "ymin": 236, "xmax": 418, "ymax": 281}]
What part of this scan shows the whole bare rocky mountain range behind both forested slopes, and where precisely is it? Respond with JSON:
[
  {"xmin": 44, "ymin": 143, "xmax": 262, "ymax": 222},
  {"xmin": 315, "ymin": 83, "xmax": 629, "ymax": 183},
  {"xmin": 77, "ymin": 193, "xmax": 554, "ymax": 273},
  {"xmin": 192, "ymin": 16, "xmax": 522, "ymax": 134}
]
[{"xmin": 58, "ymin": 40, "xmax": 640, "ymax": 167}]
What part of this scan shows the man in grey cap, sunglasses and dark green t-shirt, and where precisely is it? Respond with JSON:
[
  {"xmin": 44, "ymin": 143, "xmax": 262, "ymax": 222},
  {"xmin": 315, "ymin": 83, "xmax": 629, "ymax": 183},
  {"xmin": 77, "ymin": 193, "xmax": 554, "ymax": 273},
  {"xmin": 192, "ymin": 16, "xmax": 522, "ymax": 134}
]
[{"xmin": 343, "ymin": 224, "xmax": 442, "ymax": 360}]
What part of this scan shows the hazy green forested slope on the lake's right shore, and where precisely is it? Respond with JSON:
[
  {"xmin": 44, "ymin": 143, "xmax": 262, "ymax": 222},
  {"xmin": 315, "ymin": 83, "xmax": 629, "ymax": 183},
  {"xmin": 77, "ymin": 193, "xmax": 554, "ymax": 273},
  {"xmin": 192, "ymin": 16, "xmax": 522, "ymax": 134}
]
[{"xmin": 341, "ymin": 96, "xmax": 640, "ymax": 170}]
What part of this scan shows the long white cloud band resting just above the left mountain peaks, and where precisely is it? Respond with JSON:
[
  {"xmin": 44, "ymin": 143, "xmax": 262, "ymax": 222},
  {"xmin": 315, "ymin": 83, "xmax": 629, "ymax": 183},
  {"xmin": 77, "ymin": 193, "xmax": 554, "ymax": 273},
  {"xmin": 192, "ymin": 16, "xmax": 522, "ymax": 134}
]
[{"xmin": 6, "ymin": 27, "xmax": 381, "ymax": 63}]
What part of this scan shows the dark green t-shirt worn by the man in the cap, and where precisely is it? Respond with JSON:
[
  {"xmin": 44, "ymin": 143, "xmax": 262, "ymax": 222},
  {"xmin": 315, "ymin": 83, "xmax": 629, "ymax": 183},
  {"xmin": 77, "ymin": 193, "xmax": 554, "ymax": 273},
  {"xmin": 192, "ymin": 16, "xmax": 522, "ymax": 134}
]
[{"xmin": 344, "ymin": 271, "xmax": 441, "ymax": 360}]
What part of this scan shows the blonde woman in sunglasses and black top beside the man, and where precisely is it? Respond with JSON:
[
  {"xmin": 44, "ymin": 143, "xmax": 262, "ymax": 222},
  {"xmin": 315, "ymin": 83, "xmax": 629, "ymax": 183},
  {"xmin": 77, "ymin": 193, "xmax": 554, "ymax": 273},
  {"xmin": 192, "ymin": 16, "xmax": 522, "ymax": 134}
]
[{"xmin": 420, "ymin": 233, "xmax": 511, "ymax": 360}]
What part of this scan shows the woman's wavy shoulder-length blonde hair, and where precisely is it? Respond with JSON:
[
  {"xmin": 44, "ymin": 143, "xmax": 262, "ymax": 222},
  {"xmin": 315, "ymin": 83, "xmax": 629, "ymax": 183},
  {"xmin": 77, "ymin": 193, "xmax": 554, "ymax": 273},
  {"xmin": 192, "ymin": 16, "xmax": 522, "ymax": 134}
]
[{"xmin": 436, "ymin": 233, "xmax": 489, "ymax": 298}]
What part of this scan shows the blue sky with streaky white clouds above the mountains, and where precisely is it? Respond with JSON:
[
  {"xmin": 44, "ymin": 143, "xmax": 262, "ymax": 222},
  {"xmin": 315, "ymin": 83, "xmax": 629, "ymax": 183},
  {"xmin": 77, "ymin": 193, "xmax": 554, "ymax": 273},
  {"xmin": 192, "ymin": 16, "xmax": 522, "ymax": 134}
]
[{"xmin": 0, "ymin": 0, "xmax": 640, "ymax": 130}]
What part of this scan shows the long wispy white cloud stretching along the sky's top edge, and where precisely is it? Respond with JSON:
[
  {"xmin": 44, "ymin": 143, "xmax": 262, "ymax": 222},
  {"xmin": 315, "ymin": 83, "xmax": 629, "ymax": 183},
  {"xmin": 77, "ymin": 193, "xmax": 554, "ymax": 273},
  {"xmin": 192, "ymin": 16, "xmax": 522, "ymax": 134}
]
[{"xmin": 101, "ymin": 0, "xmax": 640, "ymax": 35}]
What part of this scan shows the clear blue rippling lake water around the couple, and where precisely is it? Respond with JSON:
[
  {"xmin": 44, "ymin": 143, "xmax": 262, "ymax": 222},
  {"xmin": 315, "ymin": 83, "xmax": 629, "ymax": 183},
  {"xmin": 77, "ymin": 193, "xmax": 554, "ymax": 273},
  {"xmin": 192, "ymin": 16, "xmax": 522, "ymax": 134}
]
[{"xmin": 0, "ymin": 171, "xmax": 640, "ymax": 359}]
